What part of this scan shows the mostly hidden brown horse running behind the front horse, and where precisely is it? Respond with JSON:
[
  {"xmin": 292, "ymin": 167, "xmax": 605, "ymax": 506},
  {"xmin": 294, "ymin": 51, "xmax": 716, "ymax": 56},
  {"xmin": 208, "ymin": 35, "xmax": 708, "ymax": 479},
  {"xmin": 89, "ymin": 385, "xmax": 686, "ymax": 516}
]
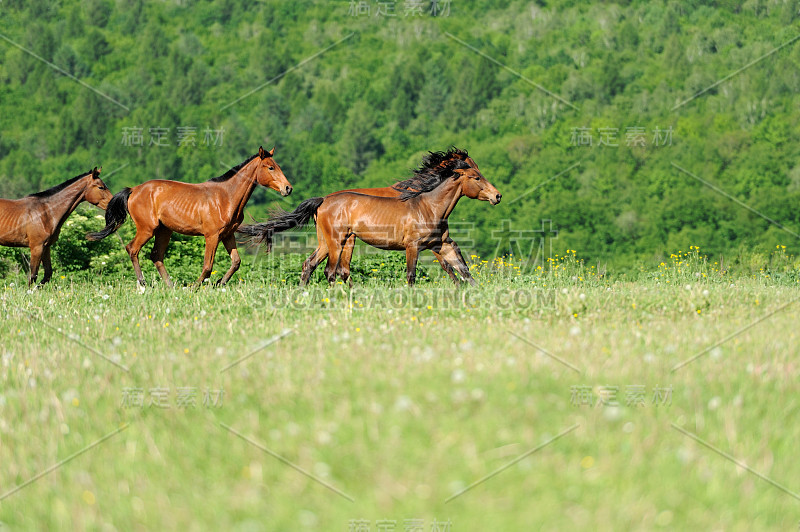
[{"xmin": 326, "ymin": 146, "xmax": 480, "ymax": 284}]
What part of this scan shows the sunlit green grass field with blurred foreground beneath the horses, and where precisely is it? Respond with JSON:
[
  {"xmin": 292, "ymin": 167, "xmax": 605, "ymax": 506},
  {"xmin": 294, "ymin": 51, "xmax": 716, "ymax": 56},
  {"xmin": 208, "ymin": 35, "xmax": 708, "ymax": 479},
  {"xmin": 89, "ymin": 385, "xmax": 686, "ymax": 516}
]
[{"xmin": 0, "ymin": 252, "xmax": 800, "ymax": 531}]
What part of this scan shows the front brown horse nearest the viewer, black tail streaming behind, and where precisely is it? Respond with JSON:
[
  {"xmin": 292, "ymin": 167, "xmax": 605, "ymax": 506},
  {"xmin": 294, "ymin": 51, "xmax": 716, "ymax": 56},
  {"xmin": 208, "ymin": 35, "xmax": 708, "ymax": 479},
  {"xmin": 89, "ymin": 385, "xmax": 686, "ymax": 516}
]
[{"xmin": 239, "ymin": 150, "xmax": 502, "ymax": 285}]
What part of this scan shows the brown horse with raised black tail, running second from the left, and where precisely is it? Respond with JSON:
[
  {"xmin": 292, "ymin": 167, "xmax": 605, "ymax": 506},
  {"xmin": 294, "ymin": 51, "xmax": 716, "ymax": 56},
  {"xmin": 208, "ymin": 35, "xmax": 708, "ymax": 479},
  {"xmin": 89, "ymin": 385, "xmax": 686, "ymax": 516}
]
[{"xmin": 86, "ymin": 147, "xmax": 292, "ymax": 286}]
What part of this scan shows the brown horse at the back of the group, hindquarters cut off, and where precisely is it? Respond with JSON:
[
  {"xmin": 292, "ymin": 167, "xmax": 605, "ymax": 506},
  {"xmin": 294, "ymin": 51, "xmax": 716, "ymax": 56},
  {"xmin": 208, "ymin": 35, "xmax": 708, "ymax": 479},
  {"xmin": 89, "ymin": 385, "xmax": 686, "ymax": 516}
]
[{"xmin": 0, "ymin": 167, "xmax": 111, "ymax": 286}]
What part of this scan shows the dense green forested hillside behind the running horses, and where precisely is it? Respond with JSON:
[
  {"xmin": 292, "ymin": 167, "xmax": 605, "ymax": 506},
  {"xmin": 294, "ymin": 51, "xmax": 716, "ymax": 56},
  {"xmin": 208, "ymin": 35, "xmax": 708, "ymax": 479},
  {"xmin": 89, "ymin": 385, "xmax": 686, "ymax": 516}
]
[{"xmin": 0, "ymin": 0, "xmax": 800, "ymax": 265}]
